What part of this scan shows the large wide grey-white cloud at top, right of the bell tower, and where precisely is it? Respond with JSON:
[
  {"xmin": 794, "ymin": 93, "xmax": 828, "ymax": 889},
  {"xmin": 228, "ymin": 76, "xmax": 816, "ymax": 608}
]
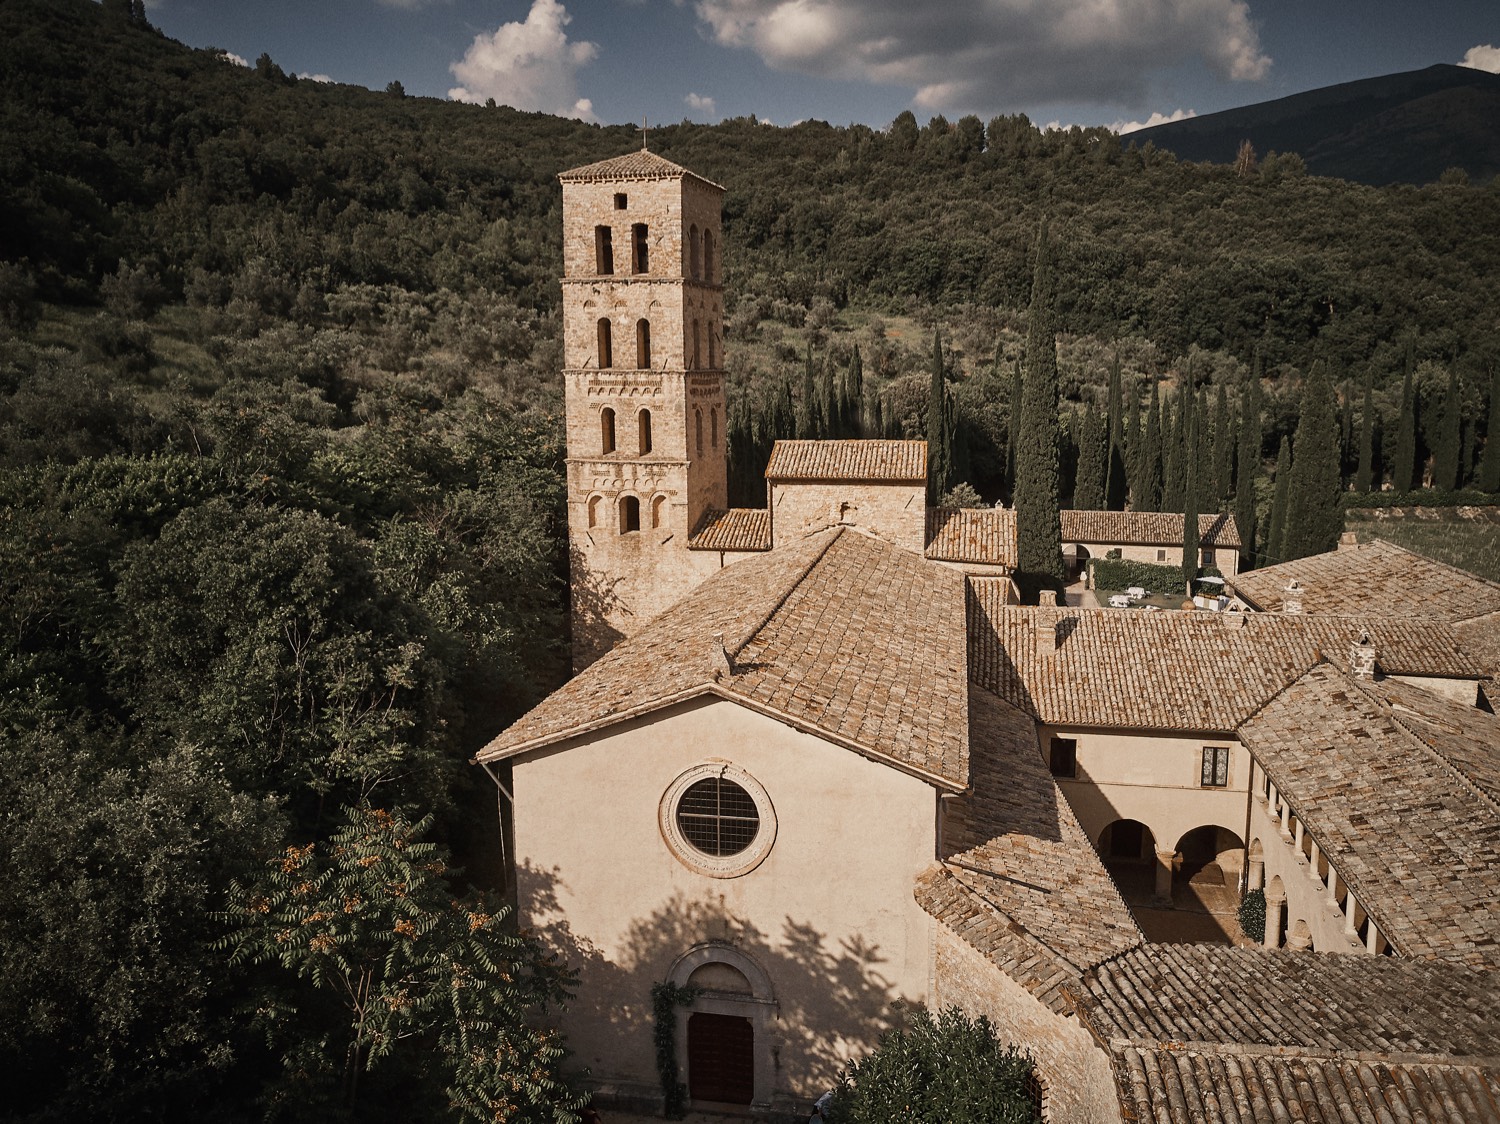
[{"xmin": 695, "ymin": 0, "xmax": 1271, "ymax": 111}]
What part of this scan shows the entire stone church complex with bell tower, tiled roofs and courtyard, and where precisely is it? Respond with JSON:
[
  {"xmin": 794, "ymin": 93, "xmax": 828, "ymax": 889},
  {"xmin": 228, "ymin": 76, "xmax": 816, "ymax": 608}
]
[{"xmin": 477, "ymin": 150, "xmax": 1500, "ymax": 1124}]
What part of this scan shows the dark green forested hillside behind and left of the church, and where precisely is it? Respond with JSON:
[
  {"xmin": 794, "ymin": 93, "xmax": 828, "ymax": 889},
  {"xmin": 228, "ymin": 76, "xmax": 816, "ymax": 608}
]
[{"xmin": 0, "ymin": 0, "xmax": 1500, "ymax": 1121}]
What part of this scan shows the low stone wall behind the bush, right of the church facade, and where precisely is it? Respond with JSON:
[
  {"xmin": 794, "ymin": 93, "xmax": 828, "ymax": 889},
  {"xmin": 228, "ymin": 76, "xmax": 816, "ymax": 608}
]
[{"xmin": 933, "ymin": 924, "xmax": 1121, "ymax": 1124}]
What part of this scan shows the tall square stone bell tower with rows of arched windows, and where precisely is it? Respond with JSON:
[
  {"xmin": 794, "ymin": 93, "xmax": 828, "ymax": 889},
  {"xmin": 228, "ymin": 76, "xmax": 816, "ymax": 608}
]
[{"xmin": 558, "ymin": 149, "xmax": 729, "ymax": 669}]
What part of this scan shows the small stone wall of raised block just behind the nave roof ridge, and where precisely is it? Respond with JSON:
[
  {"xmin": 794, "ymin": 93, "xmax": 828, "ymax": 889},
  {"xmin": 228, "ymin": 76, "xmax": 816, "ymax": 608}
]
[{"xmin": 770, "ymin": 480, "xmax": 927, "ymax": 554}]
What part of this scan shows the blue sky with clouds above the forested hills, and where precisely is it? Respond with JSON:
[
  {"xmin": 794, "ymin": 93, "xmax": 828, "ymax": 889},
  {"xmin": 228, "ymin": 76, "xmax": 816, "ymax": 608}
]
[{"xmin": 147, "ymin": 0, "xmax": 1500, "ymax": 132}]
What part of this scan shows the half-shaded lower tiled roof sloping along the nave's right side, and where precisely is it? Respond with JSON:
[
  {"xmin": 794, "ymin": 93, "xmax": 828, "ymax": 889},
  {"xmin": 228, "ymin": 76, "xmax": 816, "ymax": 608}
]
[{"xmin": 924, "ymin": 686, "xmax": 1142, "ymax": 971}]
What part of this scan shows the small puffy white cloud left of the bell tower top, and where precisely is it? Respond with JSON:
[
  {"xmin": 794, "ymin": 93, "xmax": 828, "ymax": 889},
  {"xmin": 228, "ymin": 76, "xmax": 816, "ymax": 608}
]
[{"xmin": 449, "ymin": 0, "xmax": 599, "ymax": 122}]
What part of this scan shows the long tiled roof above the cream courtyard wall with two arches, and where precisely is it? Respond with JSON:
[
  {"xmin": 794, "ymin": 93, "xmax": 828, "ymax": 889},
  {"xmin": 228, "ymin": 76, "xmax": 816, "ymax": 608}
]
[{"xmin": 969, "ymin": 591, "xmax": 1484, "ymax": 732}]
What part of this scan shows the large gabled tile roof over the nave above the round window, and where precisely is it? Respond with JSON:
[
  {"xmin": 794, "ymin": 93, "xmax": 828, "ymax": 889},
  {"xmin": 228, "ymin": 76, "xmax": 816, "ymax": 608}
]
[{"xmin": 479, "ymin": 528, "xmax": 969, "ymax": 791}]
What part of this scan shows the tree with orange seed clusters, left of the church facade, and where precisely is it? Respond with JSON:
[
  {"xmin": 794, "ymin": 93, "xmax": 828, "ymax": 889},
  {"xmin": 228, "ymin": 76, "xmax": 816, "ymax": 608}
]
[{"xmin": 222, "ymin": 807, "xmax": 587, "ymax": 1124}]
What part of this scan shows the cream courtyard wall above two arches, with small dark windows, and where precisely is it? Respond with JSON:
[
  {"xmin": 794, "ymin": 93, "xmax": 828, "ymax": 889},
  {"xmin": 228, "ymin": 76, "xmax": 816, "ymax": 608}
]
[{"xmin": 1040, "ymin": 726, "xmax": 1250, "ymax": 876}]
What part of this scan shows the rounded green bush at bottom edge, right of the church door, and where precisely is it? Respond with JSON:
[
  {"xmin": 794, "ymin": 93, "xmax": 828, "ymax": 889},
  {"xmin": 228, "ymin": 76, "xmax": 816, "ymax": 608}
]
[{"xmin": 827, "ymin": 1007, "xmax": 1041, "ymax": 1124}]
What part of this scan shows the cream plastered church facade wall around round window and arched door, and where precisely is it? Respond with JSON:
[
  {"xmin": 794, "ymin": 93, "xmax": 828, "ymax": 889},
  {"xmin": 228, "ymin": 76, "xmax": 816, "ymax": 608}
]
[{"xmin": 513, "ymin": 696, "xmax": 936, "ymax": 1110}]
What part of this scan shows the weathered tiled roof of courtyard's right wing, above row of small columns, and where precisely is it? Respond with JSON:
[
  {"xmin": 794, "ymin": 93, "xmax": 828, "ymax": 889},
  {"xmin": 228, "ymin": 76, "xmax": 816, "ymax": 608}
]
[{"xmin": 1239, "ymin": 663, "xmax": 1500, "ymax": 968}]
